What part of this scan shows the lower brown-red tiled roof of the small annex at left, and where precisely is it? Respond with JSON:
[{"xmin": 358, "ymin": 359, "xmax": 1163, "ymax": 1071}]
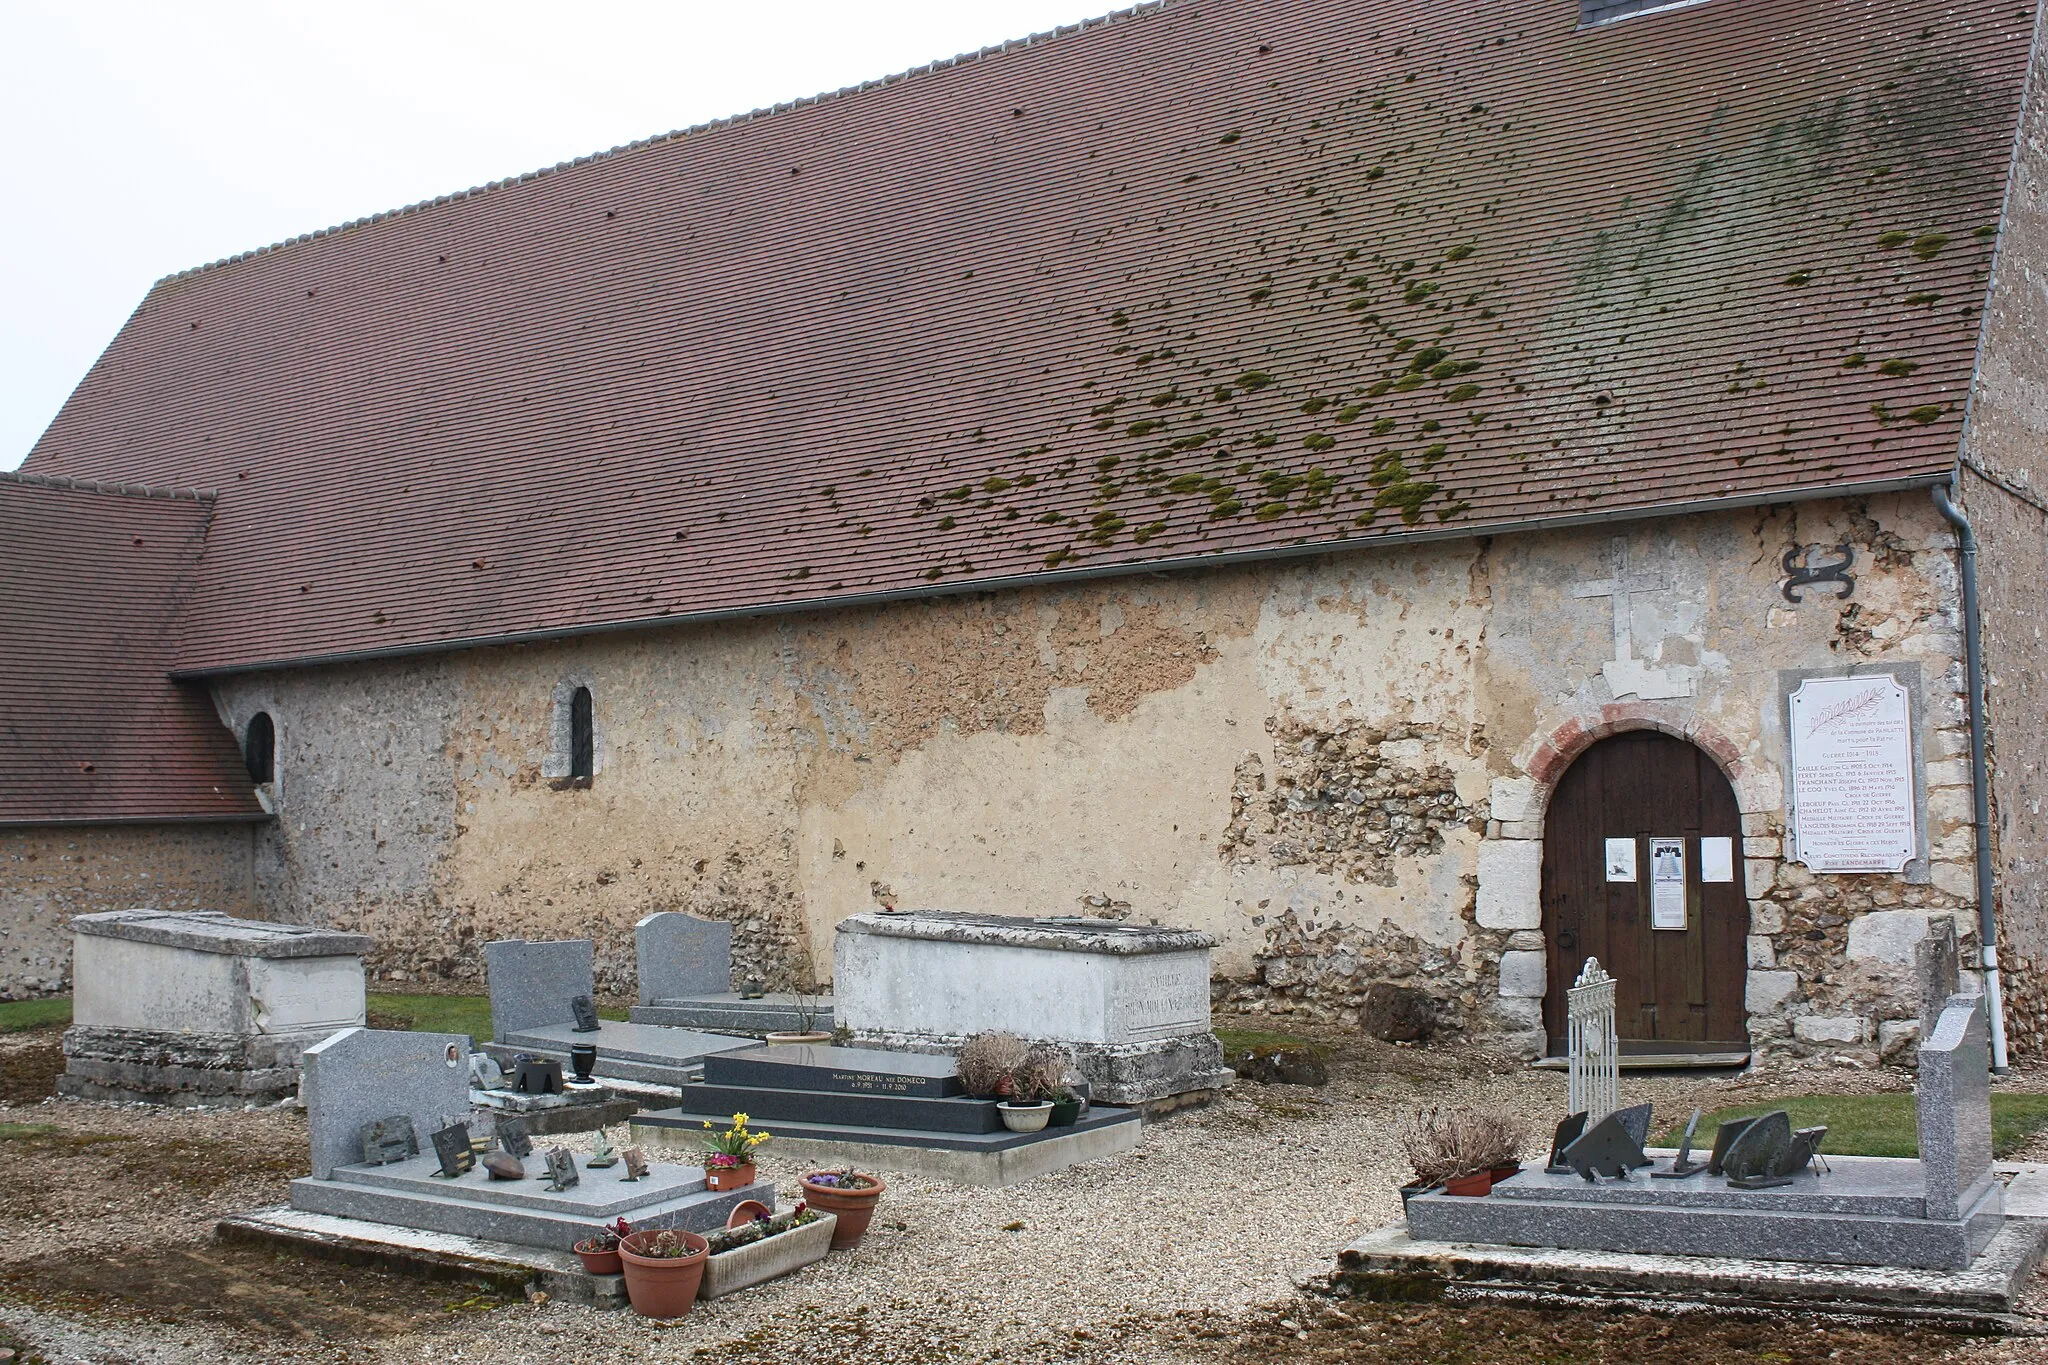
[{"xmin": 0, "ymin": 473, "xmax": 262, "ymax": 825}]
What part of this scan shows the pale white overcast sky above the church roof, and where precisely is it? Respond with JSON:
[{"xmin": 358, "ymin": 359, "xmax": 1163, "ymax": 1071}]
[{"xmin": 0, "ymin": 0, "xmax": 1120, "ymax": 469}]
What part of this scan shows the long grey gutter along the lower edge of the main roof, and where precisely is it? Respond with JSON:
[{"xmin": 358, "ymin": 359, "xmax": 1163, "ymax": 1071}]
[{"xmin": 170, "ymin": 469, "xmax": 1954, "ymax": 681}]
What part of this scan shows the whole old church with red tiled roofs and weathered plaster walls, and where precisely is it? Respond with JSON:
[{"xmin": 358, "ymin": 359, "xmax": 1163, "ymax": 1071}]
[{"xmin": 0, "ymin": 0, "xmax": 2048, "ymax": 1064}]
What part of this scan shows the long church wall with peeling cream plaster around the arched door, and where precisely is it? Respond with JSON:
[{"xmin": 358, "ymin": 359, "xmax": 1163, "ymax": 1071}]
[{"xmin": 199, "ymin": 493, "xmax": 1970, "ymax": 1060}]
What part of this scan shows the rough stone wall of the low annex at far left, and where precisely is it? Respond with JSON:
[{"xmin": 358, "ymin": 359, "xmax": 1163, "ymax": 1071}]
[{"xmin": 0, "ymin": 825, "xmax": 260, "ymax": 1001}]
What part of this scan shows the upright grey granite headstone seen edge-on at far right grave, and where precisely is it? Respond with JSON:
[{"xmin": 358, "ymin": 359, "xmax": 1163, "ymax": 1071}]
[{"xmin": 1913, "ymin": 995, "xmax": 1995, "ymax": 1218}]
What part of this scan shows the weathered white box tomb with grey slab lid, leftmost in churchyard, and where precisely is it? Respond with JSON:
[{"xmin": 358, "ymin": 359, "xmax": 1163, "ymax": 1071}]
[{"xmin": 57, "ymin": 911, "xmax": 371, "ymax": 1105}]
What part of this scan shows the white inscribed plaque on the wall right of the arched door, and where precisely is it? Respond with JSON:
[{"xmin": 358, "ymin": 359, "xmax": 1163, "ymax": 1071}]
[{"xmin": 1792, "ymin": 673, "xmax": 1919, "ymax": 872}]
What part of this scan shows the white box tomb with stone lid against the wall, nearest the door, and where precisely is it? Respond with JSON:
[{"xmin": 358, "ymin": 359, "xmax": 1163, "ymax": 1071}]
[{"xmin": 831, "ymin": 911, "xmax": 1231, "ymax": 1105}]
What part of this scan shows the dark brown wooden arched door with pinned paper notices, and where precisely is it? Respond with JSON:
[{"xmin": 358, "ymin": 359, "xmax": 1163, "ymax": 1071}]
[{"xmin": 1542, "ymin": 731, "xmax": 1749, "ymax": 1056}]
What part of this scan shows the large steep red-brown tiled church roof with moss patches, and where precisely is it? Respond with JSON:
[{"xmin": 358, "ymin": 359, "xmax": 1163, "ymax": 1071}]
[{"xmin": 27, "ymin": 0, "xmax": 2032, "ymax": 673}]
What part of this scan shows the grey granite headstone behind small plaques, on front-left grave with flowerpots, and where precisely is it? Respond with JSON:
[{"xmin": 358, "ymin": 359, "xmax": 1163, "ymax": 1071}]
[{"xmin": 299, "ymin": 1029, "xmax": 469, "ymax": 1181}]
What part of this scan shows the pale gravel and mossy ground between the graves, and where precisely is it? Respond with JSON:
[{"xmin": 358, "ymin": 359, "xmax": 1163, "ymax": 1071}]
[{"xmin": 12, "ymin": 1023, "xmax": 2048, "ymax": 1365}]
